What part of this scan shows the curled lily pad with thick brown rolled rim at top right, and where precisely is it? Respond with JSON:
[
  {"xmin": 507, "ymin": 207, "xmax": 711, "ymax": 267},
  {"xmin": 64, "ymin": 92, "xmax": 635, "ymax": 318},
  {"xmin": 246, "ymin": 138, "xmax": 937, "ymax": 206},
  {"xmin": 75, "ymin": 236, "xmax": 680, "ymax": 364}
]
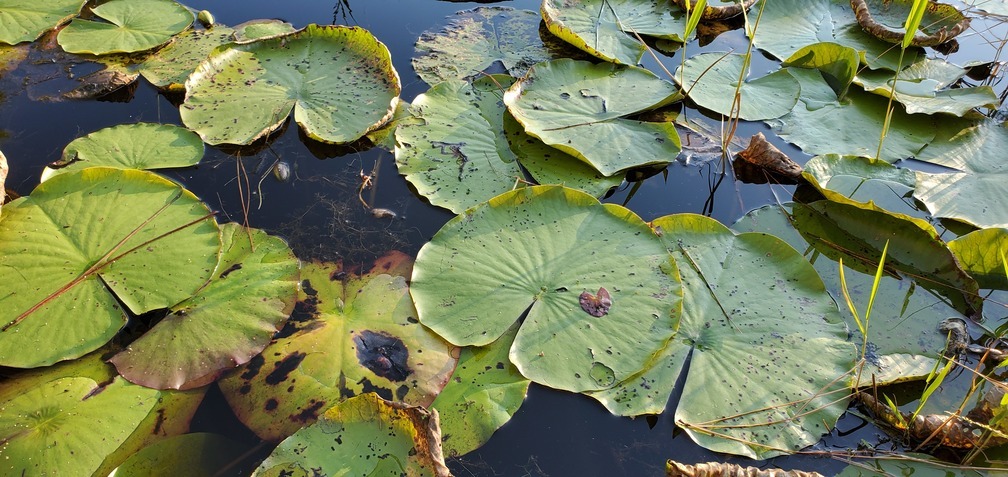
[{"xmin": 851, "ymin": 0, "xmax": 970, "ymax": 46}]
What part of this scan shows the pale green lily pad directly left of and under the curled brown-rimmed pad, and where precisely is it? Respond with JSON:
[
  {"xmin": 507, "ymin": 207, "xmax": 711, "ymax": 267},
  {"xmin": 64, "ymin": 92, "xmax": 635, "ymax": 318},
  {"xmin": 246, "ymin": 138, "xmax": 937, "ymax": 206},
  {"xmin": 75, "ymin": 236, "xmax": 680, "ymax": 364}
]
[{"xmin": 753, "ymin": 0, "xmax": 921, "ymax": 71}]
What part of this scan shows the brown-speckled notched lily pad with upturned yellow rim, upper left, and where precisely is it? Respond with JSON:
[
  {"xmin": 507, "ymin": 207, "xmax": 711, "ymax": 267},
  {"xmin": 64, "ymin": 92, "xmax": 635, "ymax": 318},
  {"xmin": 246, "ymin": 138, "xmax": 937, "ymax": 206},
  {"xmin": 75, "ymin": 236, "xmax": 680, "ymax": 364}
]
[{"xmin": 180, "ymin": 25, "xmax": 400, "ymax": 144}]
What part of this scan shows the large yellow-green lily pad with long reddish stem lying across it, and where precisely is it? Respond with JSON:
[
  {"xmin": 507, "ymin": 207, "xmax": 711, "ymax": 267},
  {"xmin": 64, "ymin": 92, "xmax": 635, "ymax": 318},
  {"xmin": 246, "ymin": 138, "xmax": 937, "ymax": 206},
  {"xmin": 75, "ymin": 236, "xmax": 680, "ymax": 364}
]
[{"xmin": 0, "ymin": 167, "xmax": 221, "ymax": 367}]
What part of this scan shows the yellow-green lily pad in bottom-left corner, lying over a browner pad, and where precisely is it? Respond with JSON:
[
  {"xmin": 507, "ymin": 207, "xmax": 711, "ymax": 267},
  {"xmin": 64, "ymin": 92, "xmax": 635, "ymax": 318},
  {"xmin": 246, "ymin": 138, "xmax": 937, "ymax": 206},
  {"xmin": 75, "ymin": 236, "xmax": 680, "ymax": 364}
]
[{"xmin": 0, "ymin": 377, "xmax": 158, "ymax": 476}]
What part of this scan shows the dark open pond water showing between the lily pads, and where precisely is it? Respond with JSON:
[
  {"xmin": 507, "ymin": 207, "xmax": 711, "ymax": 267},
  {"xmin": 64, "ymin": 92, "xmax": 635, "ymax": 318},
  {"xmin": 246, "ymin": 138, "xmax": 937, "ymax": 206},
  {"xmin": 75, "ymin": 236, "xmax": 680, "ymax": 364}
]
[{"xmin": 0, "ymin": 0, "xmax": 1003, "ymax": 476}]
